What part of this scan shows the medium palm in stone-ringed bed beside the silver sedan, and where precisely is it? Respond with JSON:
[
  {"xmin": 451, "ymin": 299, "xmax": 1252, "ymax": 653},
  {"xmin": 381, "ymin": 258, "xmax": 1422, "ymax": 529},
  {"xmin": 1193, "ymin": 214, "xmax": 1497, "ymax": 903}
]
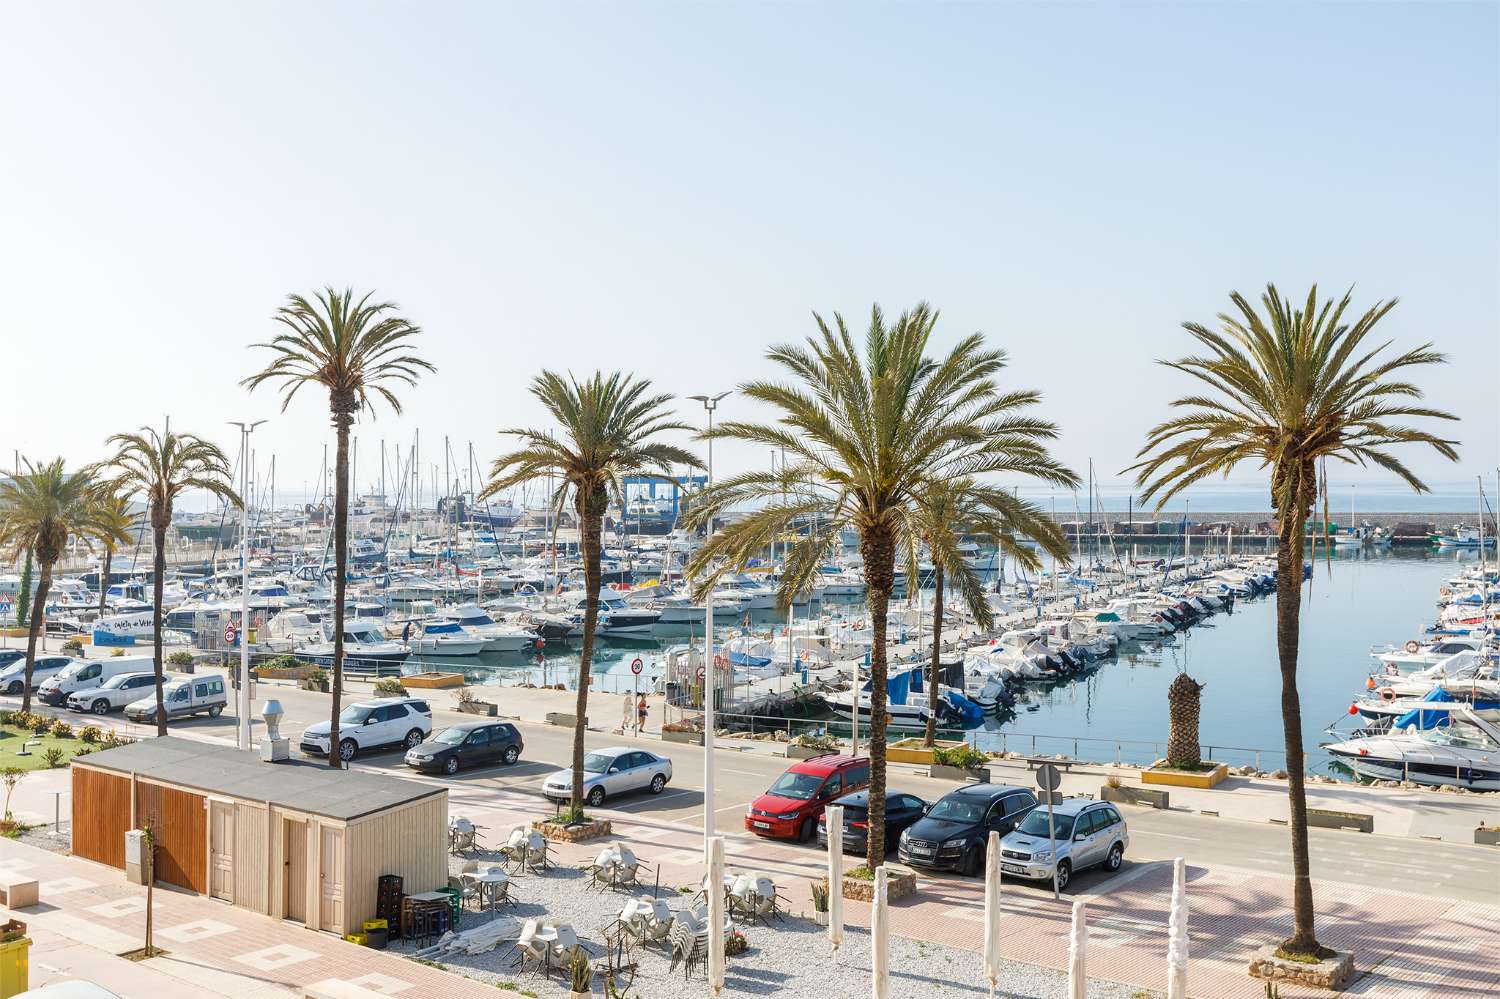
[{"xmin": 479, "ymin": 371, "xmax": 699, "ymax": 818}]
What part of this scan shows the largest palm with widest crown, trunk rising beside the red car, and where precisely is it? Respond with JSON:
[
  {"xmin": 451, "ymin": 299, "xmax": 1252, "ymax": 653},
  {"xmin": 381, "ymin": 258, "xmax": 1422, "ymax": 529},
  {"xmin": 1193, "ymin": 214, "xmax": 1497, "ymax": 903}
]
[{"xmin": 687, "ymin": 303, "xmax": 1077, "ymax": 870}]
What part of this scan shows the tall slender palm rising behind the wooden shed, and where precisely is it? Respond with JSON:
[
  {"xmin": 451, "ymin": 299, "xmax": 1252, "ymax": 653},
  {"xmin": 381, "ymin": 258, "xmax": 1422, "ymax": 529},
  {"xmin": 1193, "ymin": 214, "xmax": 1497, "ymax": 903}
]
[{"xmin": 240, "ymin": 288, "xmax": 437, "ymax": 767}]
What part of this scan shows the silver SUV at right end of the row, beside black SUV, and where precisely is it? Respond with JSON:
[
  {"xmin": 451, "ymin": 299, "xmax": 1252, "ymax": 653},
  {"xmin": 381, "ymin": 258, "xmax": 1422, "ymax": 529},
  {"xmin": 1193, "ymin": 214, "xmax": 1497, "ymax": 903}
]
[{"xmin": 1001, "ymin": 798, "xmax": 1130, "ymax": 890}]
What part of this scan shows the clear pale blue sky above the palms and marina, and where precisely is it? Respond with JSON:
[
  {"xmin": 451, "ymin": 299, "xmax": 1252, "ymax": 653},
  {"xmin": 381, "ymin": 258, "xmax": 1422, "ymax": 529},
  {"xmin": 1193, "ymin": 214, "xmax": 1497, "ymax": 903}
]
[{"xmin": 0, "ymin": 2, "xmax": 1500, "ymax": 507}]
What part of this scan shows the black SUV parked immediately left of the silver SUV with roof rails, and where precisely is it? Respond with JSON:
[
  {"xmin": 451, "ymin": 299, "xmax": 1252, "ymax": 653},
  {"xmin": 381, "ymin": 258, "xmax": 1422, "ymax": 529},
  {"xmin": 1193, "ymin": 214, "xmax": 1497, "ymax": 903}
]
[{"xmin": 900, "ymin": 785, "xmax": 1037, "ymax": 875}]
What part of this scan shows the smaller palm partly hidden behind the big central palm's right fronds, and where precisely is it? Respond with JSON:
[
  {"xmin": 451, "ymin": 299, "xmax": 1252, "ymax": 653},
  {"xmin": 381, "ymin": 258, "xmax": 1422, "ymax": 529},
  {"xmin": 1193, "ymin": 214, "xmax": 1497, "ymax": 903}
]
[{"xmin": 906, "ymin": 477, "xmax": 1068, "ymax": 746}]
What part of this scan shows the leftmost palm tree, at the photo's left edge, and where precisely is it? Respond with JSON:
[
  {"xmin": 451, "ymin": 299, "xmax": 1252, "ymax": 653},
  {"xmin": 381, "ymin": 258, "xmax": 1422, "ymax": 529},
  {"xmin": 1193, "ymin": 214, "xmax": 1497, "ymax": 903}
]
[{"xmin": 0, "ymin": 458, "xmax": 129, "ymax": 711}]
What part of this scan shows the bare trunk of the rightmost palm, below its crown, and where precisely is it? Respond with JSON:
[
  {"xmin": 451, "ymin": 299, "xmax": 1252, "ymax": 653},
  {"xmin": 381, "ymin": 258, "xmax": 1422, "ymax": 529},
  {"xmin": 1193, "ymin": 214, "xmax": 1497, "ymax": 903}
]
[{"xmin": 1277, "ymin": 503, "xmax": 1319, "ymax": 954}]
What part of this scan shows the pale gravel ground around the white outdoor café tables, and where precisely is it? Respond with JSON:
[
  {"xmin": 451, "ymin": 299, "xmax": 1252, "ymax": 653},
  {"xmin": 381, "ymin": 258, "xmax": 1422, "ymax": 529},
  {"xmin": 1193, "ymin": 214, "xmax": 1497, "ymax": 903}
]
[{"xmin": 392, "ymin": 855, "xmax": 1158, "ymax": 999}]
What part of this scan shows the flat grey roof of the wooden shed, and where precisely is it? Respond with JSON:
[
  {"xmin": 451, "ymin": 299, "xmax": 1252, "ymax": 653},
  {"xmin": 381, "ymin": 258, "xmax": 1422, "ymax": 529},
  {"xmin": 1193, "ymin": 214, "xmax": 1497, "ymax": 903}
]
[{"xmin": 75, "ymin": 735, "xmax": 447, "ymax": 821}]
